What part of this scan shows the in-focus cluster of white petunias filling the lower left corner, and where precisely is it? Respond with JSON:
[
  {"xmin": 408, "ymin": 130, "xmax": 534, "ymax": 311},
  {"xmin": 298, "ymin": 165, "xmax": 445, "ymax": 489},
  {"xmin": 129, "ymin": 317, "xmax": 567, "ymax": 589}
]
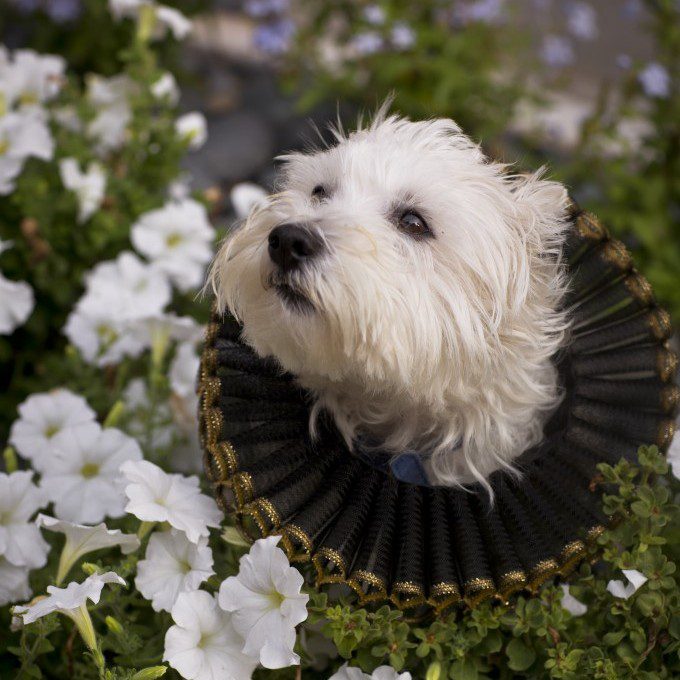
[{"xmin": 0, "ymin": 389, "xmax": 308, "ymax": 680}]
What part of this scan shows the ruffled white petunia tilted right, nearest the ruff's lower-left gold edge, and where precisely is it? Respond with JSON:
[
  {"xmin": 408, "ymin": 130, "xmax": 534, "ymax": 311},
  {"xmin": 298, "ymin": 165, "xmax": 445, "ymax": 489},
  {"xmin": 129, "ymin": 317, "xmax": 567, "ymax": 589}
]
[{"xmin": 120, "ymin": 460, "xmax": 222, "ymax": 543}]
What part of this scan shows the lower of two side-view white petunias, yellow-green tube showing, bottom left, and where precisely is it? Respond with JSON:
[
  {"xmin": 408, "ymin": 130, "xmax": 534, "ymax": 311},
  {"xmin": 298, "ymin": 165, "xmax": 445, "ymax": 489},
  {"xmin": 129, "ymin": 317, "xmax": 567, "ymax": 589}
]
[{"xmin": 13, "ymin": 571, "xmax": 126, "ymax": 650}]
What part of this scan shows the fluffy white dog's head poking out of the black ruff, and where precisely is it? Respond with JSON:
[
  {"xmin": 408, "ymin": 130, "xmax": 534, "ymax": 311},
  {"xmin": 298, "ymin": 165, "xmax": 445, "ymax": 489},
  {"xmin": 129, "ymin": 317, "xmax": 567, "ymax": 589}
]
[{"xmin": 212, "ymin": 108, "xmax": 568, "ymax": 486}]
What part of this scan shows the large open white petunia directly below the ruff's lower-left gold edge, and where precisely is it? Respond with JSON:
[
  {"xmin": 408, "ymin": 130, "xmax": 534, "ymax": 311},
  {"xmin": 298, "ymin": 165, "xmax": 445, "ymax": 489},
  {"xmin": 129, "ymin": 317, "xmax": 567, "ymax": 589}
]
[{"xmin": 219, "ymin": 536, "xmax": 309, "ymax": 668}]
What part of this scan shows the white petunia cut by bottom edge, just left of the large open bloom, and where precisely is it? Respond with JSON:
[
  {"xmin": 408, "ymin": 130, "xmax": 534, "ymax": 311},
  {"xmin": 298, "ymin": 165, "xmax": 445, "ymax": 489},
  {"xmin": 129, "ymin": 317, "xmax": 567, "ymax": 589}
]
[{"xmin": 163, "ymin": 590, "xmax": 257, "ymax": 680}]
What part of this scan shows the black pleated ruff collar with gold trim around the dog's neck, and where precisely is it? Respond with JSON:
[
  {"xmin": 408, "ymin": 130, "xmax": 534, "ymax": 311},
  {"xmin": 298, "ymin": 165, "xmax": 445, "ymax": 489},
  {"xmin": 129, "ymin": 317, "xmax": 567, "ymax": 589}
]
[{"xmin": 199, "ymin": 208, "xmax": 680, "ymax": 612}]
